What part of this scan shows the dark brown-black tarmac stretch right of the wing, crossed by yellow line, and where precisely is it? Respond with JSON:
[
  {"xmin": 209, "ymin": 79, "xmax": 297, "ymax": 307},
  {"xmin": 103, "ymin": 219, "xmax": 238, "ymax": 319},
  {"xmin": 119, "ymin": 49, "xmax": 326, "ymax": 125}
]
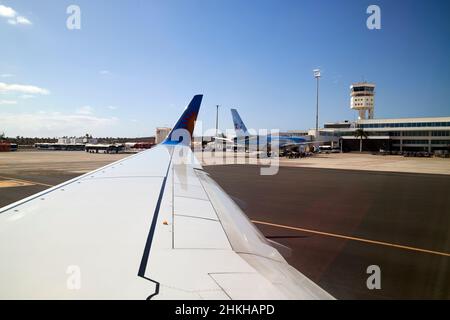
[{"xmin": 205, "ymin": 165, "xmax": 450, "ymax": 299}]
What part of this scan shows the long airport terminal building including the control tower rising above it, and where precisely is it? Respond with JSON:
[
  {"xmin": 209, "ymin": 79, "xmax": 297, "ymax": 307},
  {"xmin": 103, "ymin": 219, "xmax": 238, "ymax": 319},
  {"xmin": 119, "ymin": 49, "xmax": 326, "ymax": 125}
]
[{"xmin": 310, "ymin": 82, "xmax": 450, "ymax": 153}]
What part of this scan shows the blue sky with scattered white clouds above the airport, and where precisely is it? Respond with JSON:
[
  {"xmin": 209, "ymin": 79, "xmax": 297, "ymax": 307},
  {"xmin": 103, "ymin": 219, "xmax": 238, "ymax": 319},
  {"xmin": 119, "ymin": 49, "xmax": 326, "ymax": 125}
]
[{"xmin": 0, "ymin": 0, "xmax": 450, "ymax": 137}]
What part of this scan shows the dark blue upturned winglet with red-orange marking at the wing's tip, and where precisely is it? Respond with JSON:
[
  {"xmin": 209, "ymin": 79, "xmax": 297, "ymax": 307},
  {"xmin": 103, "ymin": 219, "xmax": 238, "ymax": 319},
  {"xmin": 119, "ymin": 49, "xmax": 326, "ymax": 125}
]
[{"xmin": 163, "ymin": 94, "xmax": 203, "ymax": 145}]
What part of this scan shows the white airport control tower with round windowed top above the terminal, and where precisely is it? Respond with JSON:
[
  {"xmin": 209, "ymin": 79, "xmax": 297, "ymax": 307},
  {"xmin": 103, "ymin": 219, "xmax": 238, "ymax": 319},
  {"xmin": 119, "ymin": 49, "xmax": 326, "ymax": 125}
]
[{"xmin": 350, "ymin": 82, "xmax": 375, "ymax": 120}]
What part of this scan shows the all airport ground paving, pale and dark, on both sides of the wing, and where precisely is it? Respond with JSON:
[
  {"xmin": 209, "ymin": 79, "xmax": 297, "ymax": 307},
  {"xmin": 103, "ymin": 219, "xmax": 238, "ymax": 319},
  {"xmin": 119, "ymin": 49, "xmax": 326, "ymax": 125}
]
[{"xmin": 0, "ymin": 151, "xmax": 450, "ymax": 299}]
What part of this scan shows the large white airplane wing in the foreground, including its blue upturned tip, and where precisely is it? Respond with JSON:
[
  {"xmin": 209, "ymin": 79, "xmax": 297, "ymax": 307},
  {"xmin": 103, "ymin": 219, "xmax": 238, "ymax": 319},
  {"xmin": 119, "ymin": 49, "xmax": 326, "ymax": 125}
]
[{"xmin": 0, "ymin": 95, "xmax": 332, "ymax": 299}]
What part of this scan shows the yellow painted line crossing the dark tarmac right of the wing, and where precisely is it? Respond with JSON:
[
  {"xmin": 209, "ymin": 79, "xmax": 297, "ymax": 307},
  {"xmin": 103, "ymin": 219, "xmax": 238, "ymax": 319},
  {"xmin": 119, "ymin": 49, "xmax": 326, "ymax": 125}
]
[{"xmin": 252, "ymin": 220, "xmax": 450, "ymax": 257}]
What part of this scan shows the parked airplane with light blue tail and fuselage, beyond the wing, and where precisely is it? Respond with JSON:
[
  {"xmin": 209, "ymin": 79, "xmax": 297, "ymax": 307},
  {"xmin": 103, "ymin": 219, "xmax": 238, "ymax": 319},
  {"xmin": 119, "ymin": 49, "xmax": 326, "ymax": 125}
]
[{"xmin": 231, "ymin": 109, "xmax": 318, "ymax": 151}]
